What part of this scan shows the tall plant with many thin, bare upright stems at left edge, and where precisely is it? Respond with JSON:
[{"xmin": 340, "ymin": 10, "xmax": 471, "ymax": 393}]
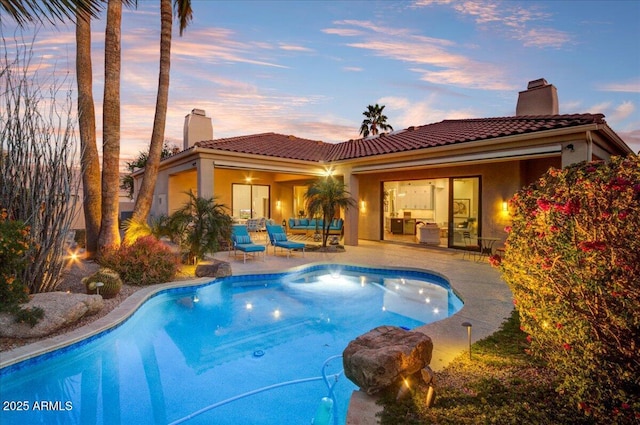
[{"xmin": 0, "ymin": 34, "xmax": 80, "ymax": 293}]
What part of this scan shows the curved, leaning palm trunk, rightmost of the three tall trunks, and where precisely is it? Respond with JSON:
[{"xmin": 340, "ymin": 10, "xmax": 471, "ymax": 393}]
[{"xmin": 131, "ymin": 0, "xmax": 173, "ymax": 238}]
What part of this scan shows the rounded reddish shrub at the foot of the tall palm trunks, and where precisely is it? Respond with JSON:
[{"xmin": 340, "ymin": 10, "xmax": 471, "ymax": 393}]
[{"xmin": 100, "ymin": 236, "xmax": 180, "ymax": 285}]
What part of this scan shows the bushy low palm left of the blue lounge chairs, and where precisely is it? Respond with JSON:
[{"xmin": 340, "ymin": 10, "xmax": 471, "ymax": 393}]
[{"xmin": 167, "ymin": 191, "xmax": 231, "ymax": 264}]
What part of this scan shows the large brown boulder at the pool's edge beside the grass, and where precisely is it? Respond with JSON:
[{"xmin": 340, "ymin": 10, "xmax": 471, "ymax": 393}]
[{"xmin": 342, "ymin": 326, "xmax": 433, "ymax": 395}]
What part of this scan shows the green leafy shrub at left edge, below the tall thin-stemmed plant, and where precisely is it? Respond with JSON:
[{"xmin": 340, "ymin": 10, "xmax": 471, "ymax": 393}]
[{"xmin": 0, "ymin": 209, "xmax": 43, "ymax": 326}]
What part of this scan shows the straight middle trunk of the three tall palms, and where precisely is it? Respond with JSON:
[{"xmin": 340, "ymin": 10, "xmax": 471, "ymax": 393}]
[{"xmin": 98, "ymin": 0, "xmax": 122, "ymax": 249}]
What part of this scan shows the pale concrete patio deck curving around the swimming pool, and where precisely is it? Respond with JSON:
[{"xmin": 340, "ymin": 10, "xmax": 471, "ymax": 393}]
[{"xmin": 0, "ymin": 241, "xmax": 513, "ymax": 425}]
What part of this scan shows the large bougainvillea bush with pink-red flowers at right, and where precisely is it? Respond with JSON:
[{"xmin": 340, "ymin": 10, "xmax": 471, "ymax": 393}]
[{"xmin": 492, "ymin": 155, "xmax": 640, "ymax": 423}]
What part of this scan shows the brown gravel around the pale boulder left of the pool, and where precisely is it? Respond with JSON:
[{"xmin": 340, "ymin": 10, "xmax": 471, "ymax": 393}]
[{"xmin": 0, "ymin": 261, "xmax": 141, "ymax": 351}]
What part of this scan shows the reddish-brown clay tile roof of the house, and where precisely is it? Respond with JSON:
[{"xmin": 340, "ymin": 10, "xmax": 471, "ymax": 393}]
[{"xmin": 196, "ymin": 114, "xmax": 605, "ymax": 162}]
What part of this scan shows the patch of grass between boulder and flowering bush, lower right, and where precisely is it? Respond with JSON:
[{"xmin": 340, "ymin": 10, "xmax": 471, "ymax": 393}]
[{"xmin": 380, "ymin": 311, "xmax": 595, "ymax": 425}]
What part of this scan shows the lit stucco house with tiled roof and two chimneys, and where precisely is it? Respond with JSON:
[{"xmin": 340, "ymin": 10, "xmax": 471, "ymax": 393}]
[{"xmin": 134, "ymin": 79, "xmax": 632, "ymax": 248}]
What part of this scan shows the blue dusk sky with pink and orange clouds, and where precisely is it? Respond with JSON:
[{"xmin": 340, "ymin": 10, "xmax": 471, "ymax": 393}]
[{"xmin": 2, "ymin": 0, "xmax": 640, "ymax": 164}]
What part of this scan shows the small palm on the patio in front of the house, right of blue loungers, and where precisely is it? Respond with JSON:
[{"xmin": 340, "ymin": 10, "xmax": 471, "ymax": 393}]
[{"xmin": 304, "ymin": 176, "xmax": 356, "ymax": 248}]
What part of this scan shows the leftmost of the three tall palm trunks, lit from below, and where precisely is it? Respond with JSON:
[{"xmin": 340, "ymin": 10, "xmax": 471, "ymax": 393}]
[{"xmin": 76, "ymin": 9, "xmax": 102, "ymax": 258}]
